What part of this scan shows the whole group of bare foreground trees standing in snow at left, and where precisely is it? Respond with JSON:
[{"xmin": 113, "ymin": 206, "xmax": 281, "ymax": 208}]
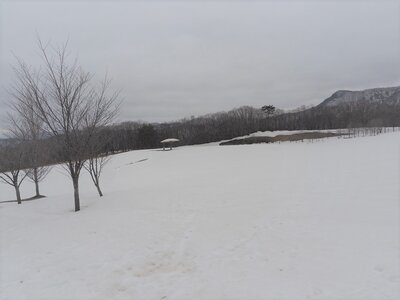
[{"xmin": 0, "ymin": 40, "xmax": 119, "ymax": 211}]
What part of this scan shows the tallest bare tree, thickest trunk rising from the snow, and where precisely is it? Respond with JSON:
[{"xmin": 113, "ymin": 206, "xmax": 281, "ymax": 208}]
[{"xmin": 12, "ymin": 40, "xmax": 118, "ymax": 211}]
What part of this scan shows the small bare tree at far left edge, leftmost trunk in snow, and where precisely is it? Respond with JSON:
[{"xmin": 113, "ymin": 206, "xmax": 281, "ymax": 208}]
[{"xmin": 0, "ymin": 142, "xmax": 27, "ymax": 204}]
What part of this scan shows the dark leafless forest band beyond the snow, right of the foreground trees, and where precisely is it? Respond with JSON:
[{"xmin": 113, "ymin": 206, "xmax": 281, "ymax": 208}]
[{"xmin": 104, "ymin": 100, "xmax": 400, "ymax": 152}]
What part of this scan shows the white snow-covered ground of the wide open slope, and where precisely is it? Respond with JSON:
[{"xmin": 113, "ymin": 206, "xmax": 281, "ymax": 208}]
[{"xmin": 0, "ymin": 132, "xmax": 400, "ymax": 300}]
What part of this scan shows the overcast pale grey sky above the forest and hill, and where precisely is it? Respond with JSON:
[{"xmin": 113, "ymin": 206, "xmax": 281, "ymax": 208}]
[{"xmin": 0, "ymin": 0, "xmax": 400, "ymax": 121}]
